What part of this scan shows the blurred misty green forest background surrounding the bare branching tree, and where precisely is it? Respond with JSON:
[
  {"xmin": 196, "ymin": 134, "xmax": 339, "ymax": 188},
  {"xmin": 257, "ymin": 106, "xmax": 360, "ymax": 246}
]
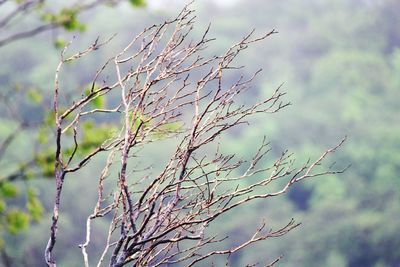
[{"xmin": 0, "ymin": 0, "xmax": 400, "ymax": 267}]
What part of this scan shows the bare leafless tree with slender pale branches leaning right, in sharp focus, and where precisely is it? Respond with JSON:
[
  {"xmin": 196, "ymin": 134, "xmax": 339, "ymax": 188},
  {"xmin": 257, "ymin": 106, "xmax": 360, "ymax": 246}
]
[{"xmin": 45, "ymin": 6, "xmax": 344, "ymax": 267}]
